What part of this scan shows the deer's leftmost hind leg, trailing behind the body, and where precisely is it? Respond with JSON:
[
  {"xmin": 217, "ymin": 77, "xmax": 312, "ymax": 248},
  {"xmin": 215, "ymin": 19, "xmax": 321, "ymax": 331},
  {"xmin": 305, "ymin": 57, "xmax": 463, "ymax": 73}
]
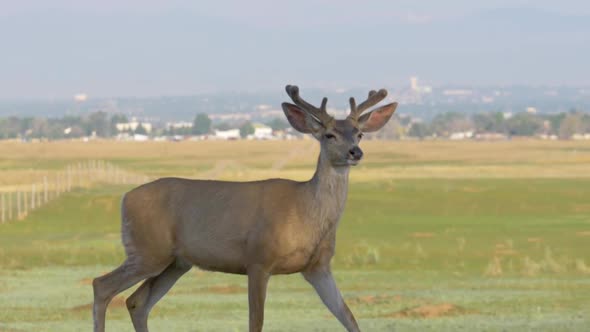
[{"xmin": 92, "ymin": 259, "xmax": 170, "ymax": 332}]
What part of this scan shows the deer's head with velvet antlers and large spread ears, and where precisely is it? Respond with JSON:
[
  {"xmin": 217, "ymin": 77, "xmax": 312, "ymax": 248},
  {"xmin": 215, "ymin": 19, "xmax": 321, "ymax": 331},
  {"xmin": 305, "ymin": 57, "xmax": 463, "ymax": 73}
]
[{"xmin": 282, "ymin": 85, "xmax": 397, "ymax": 167}]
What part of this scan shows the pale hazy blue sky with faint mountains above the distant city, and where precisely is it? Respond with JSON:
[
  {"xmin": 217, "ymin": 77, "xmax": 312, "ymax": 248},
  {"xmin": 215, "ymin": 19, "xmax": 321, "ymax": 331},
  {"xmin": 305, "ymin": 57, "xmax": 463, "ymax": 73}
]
[{"xmin": 0, "ymin": 0, "xmax": 590, "ymax": 99}]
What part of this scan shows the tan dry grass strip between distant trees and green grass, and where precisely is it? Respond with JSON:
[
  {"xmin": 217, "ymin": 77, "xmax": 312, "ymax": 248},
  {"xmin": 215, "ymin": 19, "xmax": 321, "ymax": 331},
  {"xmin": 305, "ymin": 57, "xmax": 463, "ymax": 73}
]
[{"xmin": 0, "ymin": 140, "xmax": 590, "ymax": 191}]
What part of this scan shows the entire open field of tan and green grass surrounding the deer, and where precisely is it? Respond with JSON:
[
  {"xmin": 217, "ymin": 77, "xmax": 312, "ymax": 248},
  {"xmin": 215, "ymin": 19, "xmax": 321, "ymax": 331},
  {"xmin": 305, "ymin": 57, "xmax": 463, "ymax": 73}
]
[{"xmin": 0, "ymin": 140, "xmax": 590, "ymax": 331}]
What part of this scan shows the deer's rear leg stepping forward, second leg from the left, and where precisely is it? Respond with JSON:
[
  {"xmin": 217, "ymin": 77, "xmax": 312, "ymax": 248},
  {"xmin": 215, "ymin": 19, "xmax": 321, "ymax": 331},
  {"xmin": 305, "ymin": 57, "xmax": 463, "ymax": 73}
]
[{"xmin": 127, "ymin": 260, "xmax": 192, "ymax": 332}]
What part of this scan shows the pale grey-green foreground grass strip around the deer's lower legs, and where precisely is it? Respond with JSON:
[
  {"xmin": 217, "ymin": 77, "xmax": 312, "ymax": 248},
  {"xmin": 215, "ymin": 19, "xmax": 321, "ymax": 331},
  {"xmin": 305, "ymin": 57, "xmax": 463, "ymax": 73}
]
[{"xmin": 0, "ymin": 266, "xmax": 590, "ymax": 331}]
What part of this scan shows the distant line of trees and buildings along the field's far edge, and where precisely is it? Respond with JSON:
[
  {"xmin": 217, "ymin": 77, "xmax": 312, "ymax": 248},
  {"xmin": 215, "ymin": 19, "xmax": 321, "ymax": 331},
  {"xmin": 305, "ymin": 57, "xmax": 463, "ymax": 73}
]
[{"xmin": 0, "ymin": 110, "xmax": 590, "ymax": 140}]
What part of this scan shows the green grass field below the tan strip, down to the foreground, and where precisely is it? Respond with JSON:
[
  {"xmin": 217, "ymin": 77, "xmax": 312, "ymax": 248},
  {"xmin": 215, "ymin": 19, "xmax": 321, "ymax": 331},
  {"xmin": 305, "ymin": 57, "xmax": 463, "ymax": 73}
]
[{"xmin": 0, "ymin": 179, "xmax": 590, "ymax": 331}]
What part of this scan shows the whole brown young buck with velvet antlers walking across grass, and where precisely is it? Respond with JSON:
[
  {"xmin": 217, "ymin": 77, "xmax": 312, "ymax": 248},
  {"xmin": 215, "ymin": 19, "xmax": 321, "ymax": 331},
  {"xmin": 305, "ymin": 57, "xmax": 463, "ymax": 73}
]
[{"xmin": 93, "ymin": 85, "xmax": 397, "ymax": 331}]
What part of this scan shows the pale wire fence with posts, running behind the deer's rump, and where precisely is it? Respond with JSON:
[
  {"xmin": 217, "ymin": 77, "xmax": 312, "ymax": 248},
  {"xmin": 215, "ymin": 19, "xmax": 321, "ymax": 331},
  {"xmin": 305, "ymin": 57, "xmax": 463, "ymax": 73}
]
[{"xmin": 0, "ymin": 160, "xmax": 150, "ymax": 223}]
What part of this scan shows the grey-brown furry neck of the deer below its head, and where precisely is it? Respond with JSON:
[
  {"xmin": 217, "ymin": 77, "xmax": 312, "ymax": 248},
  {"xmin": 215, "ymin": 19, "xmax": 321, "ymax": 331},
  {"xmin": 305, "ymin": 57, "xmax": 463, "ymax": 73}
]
[{"xmin": 307, "ymin": 152, "xmax": 350, "ymax": 228}]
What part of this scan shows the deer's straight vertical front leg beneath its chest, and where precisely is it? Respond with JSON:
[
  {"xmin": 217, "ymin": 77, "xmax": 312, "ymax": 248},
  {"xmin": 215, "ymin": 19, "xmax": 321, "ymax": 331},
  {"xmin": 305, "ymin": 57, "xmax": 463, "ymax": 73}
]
[{"xmin": 248, "ymin": 266, "xmax": 270, "ymax": 332}]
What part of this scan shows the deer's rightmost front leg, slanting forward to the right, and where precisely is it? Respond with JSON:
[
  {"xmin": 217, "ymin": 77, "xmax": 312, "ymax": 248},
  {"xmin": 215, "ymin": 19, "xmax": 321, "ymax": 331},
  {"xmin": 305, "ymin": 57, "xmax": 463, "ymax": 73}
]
[{"xmin": 302, "ymin": 267, "xmax": 360, "ymax": 332}]
